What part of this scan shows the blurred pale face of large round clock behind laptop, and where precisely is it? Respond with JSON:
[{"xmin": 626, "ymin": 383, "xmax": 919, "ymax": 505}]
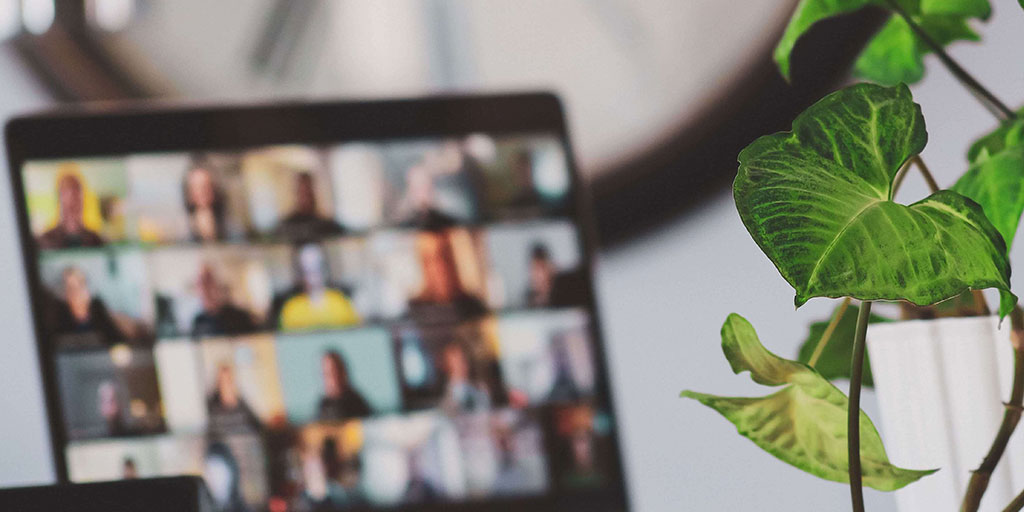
[{"xmin": 116, "ymin": 0, "xmax": 795, "ymax": 177}]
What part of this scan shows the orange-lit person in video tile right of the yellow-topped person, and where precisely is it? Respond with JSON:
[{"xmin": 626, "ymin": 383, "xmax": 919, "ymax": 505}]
[{"xmin": 409, "ymin": 231, "xmax": 487, "ymax": 321}]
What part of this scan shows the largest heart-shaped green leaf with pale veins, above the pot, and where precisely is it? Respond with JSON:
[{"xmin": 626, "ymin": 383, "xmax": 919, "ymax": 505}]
[{"xmin": 733, "ymin": 84, "xmax": 1017, "ymax": 315}]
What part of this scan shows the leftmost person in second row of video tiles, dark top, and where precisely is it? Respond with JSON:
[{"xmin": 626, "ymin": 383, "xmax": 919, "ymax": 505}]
[{"xmin": 53, "ymin": 266, "xmax": 128, "ymax": 346}]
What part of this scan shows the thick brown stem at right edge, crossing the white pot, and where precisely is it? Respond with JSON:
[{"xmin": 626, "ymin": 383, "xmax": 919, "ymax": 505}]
[{"xmin": 961, "ymin": 306, "xmax": 1024, "ymax": 512}]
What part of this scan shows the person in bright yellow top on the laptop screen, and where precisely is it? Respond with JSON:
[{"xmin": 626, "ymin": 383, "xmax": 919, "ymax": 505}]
[{"xmin": 278, "ymin": 244, "xmax": 361, "ymax": 331}]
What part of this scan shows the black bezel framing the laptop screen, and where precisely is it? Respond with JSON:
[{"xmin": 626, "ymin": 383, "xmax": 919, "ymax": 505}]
[{"xmin": 5, "ymin": 92, "xmax": 628, "ymax": 511}]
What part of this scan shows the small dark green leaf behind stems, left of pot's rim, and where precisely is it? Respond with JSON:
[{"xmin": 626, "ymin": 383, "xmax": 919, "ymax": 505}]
[{"xmin": 797, "ymin": 304, "xmax": 890, "ymax": 387}]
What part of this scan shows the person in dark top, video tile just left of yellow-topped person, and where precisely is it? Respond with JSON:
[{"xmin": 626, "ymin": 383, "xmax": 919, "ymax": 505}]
[{"xmin": 191, "ymin": 264, "xmax": 257, "ymax": 338}]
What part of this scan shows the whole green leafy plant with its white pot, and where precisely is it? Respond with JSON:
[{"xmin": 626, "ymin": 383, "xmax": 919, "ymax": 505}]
[{"xmin": 682, "ymin": 0, "xmax": 1024, "ymax": 511}]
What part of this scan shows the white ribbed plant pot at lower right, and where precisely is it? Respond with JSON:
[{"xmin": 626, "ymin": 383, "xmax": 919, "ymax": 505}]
[{"xmin": 867, "ymin": 316, "xmax": 1024, "ymax": 512}]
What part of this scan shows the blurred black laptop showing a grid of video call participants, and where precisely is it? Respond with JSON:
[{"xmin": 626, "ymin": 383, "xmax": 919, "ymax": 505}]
[{"xmin": 6, "ymin": 94, "xmax": 627, "ymax": 511}]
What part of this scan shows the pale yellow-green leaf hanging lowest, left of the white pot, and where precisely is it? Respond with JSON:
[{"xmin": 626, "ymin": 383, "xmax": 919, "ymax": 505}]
[{"xmin": 682, "ymin": 313, "xmax": 936, "ymax": 490}]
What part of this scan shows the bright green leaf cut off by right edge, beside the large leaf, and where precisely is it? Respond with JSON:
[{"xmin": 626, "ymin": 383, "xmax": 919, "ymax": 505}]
[{"xmin": 952, "ymin": 145, "xmax": 1024, "ymax": 250}]
